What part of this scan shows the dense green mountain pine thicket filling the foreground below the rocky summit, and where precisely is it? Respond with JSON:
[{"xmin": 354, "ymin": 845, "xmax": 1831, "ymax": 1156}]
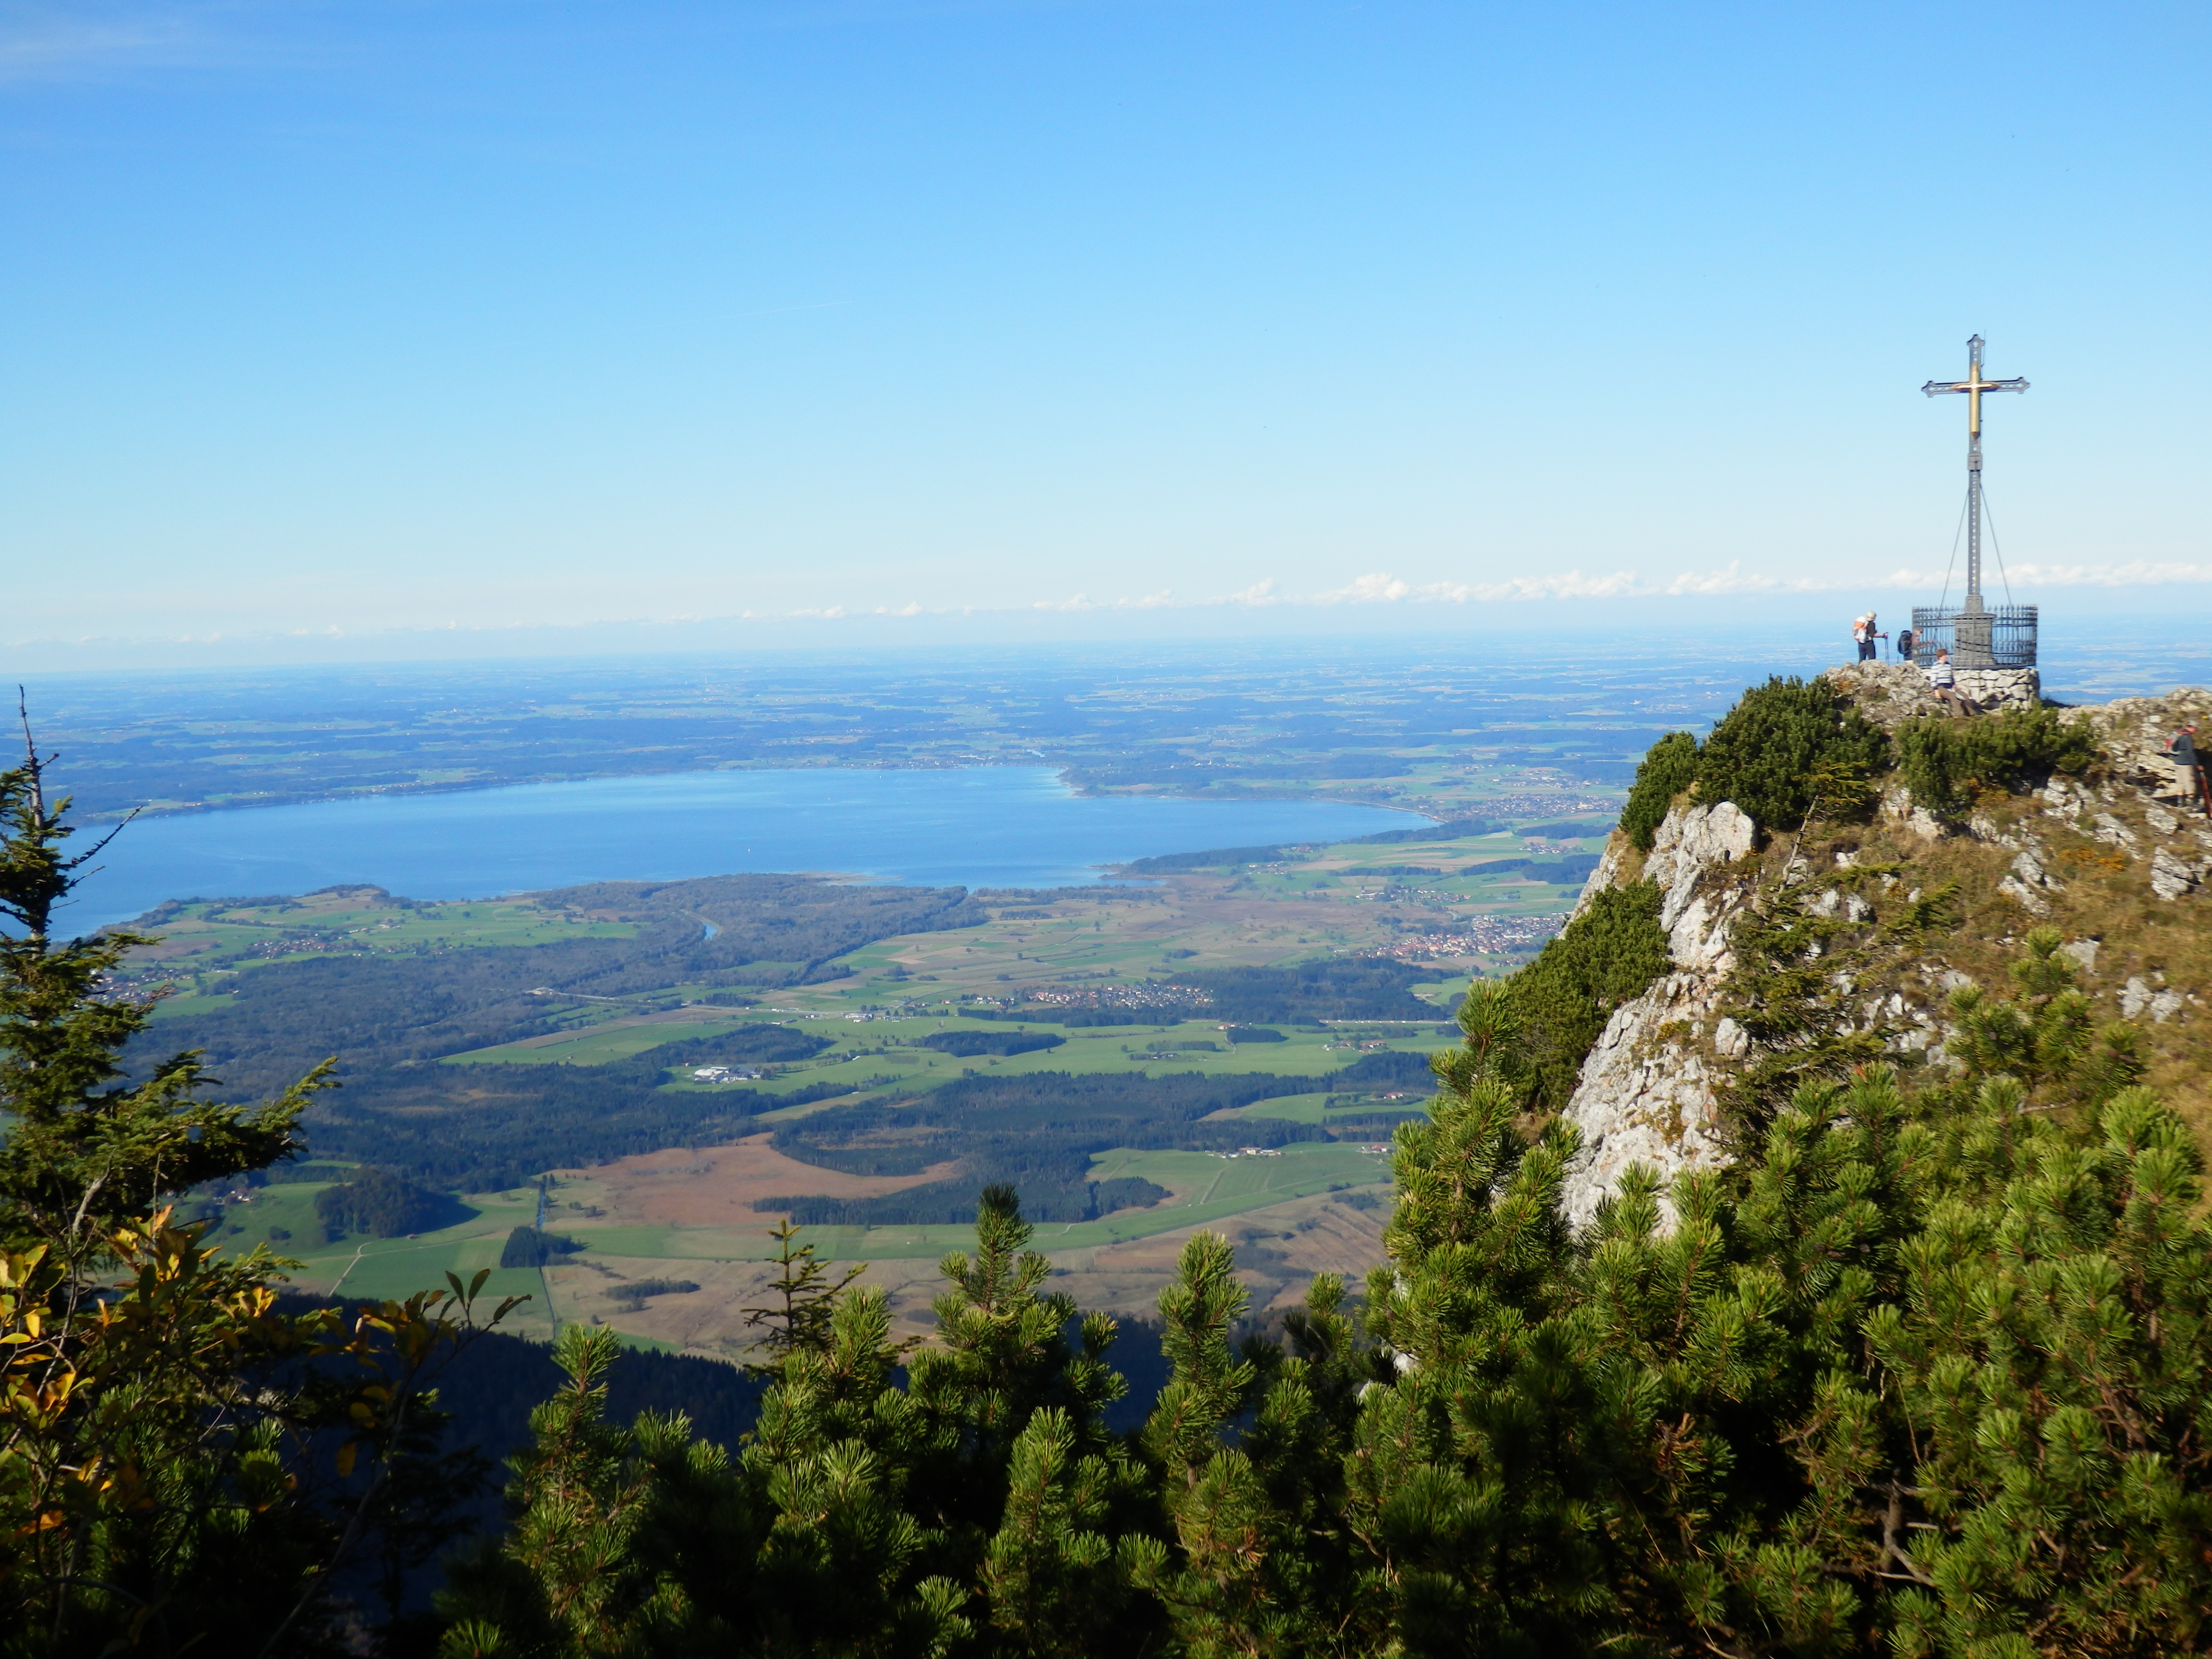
[{"xmin": 447, "ymin": 934, "xmax": 2212, "ymax": 1659}]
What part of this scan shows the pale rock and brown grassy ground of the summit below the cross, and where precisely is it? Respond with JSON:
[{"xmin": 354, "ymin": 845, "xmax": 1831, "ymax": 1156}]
[{"xmin": 1562, "ymin": 663, "xmax": 2212, "ymax": 1227}]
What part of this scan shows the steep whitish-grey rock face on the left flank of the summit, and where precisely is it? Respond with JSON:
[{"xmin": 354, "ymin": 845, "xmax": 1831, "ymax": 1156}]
[{"xmin": 1560, "ymin": 801, "xmax": 1756, "ymax": 1227}]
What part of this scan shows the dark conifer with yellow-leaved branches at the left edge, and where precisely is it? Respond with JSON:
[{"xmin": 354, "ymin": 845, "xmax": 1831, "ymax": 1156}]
[{"xmin": 0, "ymin": 725, "xmax": 517, "ymax": 1655}]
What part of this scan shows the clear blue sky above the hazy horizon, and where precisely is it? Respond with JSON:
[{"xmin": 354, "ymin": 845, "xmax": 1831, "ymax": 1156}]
[{"xmin": 0, "ymin": 0, "xmax": 2212, "ymax": 666}]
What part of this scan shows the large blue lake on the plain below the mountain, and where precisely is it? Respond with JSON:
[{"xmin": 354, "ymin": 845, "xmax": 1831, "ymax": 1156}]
[{"xmin": 64, "ymin": 768, "xmax": 1422, "ymax": 931}]
